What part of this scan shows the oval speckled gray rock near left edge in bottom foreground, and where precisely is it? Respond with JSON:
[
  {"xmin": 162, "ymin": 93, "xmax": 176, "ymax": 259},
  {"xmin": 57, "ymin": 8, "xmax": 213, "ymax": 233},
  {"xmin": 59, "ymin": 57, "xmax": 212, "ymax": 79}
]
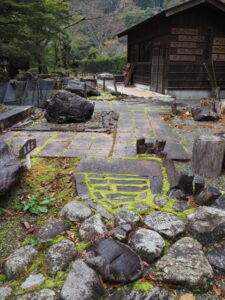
[{"xmin": 4, "ymin": 246, "xmax": 37, "ymax": 280}]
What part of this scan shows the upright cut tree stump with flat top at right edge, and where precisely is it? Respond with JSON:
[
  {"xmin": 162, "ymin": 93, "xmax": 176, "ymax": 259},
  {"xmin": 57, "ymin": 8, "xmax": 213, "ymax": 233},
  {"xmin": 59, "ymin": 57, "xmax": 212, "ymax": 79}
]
[{"xmin": 192, "ymin": 136, "xmax": 225, "ymax": 178}]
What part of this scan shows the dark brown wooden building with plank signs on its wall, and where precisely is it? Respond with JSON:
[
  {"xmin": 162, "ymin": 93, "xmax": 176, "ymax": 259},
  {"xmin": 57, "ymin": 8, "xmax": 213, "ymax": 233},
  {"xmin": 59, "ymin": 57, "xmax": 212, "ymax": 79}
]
[{"xmin": 118, "ymin": 0, "xmax": 225, "ymax": 99}]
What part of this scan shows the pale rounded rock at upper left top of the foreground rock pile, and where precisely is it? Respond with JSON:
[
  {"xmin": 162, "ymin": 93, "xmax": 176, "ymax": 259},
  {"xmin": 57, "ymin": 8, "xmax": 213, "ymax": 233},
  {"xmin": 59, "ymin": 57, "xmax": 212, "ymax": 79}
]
[{"xmin": 59, "ymin": 200, "xmax": 91, "ymax": 222}]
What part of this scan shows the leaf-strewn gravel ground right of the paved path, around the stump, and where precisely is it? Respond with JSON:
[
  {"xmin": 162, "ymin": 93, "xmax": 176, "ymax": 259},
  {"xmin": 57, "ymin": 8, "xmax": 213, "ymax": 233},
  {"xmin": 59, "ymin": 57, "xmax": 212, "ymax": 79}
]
[{"xmin": 165, "ymin": 111, "xmax": 225, "ymax": 192}]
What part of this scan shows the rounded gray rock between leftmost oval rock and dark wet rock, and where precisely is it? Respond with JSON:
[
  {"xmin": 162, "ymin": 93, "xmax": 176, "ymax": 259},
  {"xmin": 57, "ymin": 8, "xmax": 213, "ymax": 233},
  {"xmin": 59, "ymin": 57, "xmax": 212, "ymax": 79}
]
[{"xmin": 46, "ymin": 240, "xmax": 77, "ymax": 276}]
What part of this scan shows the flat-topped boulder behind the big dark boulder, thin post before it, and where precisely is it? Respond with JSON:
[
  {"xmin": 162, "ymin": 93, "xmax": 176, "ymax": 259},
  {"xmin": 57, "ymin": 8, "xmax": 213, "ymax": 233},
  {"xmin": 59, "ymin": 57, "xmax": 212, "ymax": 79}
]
[{"xmin": 63, "ymin": 78, "xmax": 100, "ymax": 97}]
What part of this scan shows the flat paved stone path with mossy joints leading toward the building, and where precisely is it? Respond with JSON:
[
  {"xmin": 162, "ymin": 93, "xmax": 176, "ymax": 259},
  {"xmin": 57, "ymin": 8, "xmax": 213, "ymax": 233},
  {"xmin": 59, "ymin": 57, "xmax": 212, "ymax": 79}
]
[{"xmin": 2, "ymin": 101, "xmax": 190, "ymax": 161}]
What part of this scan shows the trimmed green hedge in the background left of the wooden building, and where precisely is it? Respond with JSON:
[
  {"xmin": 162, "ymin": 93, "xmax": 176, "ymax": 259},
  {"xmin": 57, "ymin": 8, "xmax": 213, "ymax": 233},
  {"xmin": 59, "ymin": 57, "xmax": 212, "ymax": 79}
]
[{"xmin": 81, "ymin": 55, "xmax": 126, "ymax": 74}]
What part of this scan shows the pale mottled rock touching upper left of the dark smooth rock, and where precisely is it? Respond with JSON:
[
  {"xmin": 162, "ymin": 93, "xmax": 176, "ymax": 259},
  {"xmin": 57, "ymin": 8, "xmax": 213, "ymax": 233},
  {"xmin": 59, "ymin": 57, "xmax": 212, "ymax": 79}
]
[{"xmin": 79, "ymin": 215, "xmax": 107, "ymax": 241}]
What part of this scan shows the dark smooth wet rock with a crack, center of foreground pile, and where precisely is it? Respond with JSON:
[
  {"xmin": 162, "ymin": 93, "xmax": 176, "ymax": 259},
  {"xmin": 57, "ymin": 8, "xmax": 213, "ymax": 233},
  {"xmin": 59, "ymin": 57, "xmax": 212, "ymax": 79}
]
[{"xmin": 85, "ymin": 239, "xmax": 143, "ymax": 283}]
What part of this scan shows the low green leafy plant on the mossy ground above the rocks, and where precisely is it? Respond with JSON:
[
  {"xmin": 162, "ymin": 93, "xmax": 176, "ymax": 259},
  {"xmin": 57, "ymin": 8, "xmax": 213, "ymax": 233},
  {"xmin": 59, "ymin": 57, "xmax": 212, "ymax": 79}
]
[{"xmin": 12, "ymin": 194, "xmax": 55, "ymax": 215}]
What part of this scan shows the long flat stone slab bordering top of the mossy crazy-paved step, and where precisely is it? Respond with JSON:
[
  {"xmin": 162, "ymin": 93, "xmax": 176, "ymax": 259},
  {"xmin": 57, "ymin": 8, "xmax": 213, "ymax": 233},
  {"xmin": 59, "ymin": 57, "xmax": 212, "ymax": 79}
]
[{"xmin": 76, "ymin": 159, "xmax": 161, "ymax": 177}]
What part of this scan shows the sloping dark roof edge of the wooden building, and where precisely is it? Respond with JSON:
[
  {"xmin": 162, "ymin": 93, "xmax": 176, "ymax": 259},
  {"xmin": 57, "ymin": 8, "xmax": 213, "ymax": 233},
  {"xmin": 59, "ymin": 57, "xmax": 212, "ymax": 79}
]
[{"xmin": 118, "ymin": 0, "xmax": 225, "ymax": 37}]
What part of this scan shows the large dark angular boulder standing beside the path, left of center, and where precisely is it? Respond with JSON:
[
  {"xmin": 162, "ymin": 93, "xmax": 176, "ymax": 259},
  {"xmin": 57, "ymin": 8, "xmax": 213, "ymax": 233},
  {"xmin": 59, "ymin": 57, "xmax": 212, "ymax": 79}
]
[{"xmin": 45, "ymin": 91, "xmax": 94, "ymax": 124}]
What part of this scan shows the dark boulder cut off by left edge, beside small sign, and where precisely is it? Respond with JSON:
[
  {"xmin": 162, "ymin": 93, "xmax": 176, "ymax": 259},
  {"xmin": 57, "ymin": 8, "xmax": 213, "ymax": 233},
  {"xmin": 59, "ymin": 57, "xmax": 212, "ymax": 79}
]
[{"xmin": 0, "ymin": 139, "xmax": 23, "ymax": 197}]
